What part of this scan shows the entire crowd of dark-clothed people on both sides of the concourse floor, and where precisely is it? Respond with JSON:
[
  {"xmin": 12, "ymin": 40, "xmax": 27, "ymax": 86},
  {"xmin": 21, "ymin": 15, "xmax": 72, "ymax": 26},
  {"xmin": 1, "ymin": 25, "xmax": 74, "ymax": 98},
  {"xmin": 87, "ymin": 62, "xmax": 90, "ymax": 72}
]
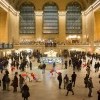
[{"xmin": 0, "ymin": 50, "xmax": 100, "ymax": 100}]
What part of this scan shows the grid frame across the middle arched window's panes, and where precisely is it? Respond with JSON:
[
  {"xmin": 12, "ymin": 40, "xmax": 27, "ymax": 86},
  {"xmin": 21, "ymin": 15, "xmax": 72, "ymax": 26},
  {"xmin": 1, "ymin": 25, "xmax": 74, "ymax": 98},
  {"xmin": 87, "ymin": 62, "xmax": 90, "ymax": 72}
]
[{"xmin": 42, "ymin": 4, "xmax": 59, "ymax": 34}]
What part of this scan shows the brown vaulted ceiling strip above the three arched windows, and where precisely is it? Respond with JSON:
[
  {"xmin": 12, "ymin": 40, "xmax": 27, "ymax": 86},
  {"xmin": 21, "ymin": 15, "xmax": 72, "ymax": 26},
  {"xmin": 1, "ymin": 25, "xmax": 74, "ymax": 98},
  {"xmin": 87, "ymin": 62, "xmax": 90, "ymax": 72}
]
[{"xmin": 6, "ymin": 0, "xmax": 96, "ymax": 10}]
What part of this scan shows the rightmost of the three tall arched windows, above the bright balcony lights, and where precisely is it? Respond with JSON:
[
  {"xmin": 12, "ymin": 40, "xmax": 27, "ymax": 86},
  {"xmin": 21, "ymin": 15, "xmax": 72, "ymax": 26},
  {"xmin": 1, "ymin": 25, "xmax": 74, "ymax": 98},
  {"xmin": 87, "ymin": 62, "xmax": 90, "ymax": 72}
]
[{"xmin": 66, "ymin": 2, "xmax": 82, "ymax": 34}]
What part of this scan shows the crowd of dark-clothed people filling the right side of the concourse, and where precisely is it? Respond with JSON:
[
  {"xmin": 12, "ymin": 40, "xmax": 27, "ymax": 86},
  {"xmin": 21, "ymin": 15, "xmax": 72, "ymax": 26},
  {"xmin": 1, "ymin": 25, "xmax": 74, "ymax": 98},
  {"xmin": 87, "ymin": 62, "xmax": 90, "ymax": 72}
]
[{"xmin": 57, "ymin": 52, "xmax": 100, "ymax": 100}]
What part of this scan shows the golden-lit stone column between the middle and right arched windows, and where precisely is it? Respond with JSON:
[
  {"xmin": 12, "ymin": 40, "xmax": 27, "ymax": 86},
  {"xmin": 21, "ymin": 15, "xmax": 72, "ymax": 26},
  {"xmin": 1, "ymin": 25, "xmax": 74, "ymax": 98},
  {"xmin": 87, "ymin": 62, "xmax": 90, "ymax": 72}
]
[{"xmin": 59, "ymin": 11, "xmax": 66, "ymax": 42}]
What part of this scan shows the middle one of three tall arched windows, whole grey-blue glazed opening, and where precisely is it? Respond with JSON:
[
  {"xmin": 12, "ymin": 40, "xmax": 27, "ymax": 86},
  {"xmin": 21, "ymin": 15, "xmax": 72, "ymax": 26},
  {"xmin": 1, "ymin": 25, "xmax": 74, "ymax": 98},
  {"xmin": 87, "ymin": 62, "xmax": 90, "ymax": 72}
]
[{"xmin": 43, "ymin": 4, "xmax": 58, "ymax": 33}]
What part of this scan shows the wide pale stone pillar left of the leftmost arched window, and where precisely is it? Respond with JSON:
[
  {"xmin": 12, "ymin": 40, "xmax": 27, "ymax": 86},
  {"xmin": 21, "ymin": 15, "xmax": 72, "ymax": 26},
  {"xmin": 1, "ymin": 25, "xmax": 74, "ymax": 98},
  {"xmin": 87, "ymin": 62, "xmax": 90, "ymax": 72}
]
[{"xmin": 8, "ymin": 11, "xmax": 19, "ymax": 44}]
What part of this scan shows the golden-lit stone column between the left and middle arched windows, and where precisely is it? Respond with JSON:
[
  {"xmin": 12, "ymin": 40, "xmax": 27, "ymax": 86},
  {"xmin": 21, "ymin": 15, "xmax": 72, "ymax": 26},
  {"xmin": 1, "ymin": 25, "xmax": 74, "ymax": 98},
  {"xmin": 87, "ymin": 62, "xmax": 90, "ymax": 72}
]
[{"xmin": 35, "ymin": 11, "xmax": 43, "ymax": 40}]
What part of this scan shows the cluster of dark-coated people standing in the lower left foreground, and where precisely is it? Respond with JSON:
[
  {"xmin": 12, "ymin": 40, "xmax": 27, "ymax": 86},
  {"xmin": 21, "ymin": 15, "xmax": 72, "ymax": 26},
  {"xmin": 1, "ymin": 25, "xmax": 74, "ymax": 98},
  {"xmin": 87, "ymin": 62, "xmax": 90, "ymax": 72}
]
[{"xmin": 0, "ymin": 69, "xmax": 30, "ymax": 100}]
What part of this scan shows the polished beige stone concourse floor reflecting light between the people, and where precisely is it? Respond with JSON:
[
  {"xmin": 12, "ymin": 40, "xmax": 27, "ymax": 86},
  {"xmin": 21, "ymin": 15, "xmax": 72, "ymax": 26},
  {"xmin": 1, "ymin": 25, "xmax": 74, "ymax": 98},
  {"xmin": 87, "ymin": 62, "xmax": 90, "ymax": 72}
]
[{"xmin": 0, "ymin": 58, "xmax": 100, "ymax": 100}]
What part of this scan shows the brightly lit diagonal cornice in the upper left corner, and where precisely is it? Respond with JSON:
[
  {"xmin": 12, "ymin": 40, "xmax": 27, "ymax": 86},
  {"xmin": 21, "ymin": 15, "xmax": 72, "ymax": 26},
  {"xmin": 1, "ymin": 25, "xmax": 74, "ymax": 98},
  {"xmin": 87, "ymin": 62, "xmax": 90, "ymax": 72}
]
[{"xmin": 0, "ymin": 0, "xmax": 19, "ymax": 16}]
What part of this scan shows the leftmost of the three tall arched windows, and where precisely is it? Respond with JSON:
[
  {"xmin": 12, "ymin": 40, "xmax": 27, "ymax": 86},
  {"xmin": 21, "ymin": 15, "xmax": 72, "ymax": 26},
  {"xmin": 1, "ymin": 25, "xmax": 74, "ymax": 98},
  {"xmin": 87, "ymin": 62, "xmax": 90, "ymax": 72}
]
[{"xmin": 20, "ymin": 3, "xmax": 35, "ymax": 34}]
